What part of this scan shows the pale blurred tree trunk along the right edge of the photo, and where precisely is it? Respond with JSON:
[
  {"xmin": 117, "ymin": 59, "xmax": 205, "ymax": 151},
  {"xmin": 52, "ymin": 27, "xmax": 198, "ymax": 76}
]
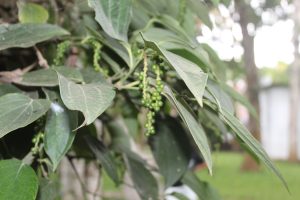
[{"xmin": 289, "ymin": 0, "xmax": 300, "ymax": 162}]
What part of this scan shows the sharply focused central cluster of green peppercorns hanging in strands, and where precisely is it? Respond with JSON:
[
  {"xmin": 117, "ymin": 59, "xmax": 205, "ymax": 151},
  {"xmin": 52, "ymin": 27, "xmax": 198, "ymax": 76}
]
[{"xmin": 138, "ymin": 55, "xmax": 163, "ymax": 135}]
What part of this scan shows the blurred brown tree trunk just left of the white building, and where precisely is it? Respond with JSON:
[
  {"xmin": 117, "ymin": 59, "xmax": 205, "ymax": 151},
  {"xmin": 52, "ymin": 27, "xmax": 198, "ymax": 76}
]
[{"xmin": 235, "ymin": 0, "xmax": 260, "ymax": 170}]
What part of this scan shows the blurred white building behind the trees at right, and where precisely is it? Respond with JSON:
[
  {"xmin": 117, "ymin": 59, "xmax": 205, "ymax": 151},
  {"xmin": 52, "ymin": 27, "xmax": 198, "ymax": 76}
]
[{"xmin": 259, "ymin": 86, "xmax": 300, "ymax": 160}]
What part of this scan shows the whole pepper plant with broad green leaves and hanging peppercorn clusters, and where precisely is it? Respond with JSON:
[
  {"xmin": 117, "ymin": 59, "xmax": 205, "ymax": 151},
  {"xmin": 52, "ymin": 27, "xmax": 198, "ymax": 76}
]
[{"xmin": 0, "ymin": 0, "xmax": 285, "ymax": 200}]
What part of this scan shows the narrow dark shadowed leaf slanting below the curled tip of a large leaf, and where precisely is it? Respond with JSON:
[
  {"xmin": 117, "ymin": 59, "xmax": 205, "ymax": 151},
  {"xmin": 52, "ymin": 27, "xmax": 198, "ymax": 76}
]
[{"xmin": 84, "ymin": 135, "xmax": 120, "ymax": 185}]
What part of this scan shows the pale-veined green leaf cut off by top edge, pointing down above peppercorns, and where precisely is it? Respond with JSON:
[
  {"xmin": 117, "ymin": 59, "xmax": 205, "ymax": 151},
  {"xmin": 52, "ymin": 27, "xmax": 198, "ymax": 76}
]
[{"xmin": 89, "ymin": 0, "xmax": 132, "ymax": 42}]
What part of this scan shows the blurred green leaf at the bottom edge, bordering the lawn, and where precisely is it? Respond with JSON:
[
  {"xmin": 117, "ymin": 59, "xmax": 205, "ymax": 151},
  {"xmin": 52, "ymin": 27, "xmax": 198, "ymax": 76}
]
[{"xmin": 182, "ymin": 172, "xmax": 221, "ymax": 200}]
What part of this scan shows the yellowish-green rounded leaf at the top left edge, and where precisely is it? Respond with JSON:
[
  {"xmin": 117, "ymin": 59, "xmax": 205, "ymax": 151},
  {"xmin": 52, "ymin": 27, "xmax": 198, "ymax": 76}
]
[{"xmin": 18, "ymin": 1, "xmax": 49, "ymax": 23}]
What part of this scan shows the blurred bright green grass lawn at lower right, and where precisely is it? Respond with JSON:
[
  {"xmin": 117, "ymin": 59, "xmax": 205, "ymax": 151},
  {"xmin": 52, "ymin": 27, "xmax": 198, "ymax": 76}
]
[{"xmin": 198, "ymin": 152, "xmax": 300, "ymax": 200}]
